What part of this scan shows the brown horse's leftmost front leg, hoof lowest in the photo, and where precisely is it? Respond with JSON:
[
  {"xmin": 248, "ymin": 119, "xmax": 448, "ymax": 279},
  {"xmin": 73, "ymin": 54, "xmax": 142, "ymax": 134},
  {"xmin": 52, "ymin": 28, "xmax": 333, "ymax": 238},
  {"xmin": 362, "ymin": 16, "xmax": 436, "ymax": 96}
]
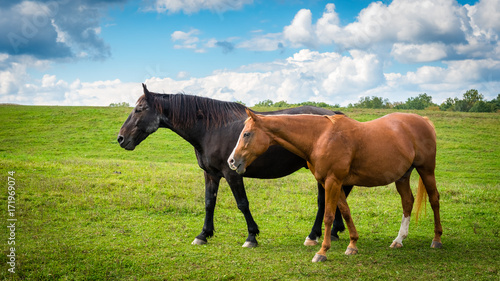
[{"xmin": 312, "ymin": 178, "xmax": 345, "ymax": 262}]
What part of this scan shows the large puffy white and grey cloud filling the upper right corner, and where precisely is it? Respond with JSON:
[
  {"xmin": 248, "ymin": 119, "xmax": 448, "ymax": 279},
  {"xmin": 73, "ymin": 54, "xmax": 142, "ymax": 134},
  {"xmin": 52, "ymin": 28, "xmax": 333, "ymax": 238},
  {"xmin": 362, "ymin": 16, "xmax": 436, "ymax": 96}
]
[{"xmin": 252, "ymin": 0, "xmax": 500, "ymax": 63}]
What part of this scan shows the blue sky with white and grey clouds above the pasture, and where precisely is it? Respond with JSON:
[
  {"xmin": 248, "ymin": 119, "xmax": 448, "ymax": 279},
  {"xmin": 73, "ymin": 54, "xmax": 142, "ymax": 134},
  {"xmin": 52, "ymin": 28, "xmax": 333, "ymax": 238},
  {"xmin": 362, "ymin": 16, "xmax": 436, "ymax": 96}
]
[{"xmin": 0, "ymin": 0, "xmax": 500, "ymax": 106}]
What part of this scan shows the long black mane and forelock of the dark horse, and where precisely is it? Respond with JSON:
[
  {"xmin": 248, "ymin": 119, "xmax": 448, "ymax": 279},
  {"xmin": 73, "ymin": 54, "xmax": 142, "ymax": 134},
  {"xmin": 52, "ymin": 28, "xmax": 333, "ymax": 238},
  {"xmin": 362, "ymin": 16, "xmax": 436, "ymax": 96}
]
[{"xmin": 137, "ymin": 92, "xmax": 247, "ymax": 128}]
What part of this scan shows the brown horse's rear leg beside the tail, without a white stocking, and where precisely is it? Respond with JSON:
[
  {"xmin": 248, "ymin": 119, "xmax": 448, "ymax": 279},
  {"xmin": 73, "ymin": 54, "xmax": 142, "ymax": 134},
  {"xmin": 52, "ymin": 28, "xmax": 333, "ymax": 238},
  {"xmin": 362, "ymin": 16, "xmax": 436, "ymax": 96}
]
[{"xmin": 417, "ymin": 168, "xmax": 443, "ymax": 248}]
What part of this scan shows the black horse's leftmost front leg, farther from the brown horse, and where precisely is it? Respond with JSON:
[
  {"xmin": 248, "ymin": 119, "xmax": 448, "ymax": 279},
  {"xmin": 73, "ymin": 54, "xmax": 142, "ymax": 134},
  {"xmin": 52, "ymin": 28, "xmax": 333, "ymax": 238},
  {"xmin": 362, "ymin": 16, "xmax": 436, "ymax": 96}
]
[{"xmin": 192, "ymin": 172, "xmax": 220, "ymax": 245}]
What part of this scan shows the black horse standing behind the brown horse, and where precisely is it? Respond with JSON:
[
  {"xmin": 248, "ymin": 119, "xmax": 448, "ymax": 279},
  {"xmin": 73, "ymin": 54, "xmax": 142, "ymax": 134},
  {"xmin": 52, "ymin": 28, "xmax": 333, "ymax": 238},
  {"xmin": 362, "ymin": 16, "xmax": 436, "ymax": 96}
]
[{"xmin": 118, "ymin": 84, "xmax": 352, "ymax": 247}]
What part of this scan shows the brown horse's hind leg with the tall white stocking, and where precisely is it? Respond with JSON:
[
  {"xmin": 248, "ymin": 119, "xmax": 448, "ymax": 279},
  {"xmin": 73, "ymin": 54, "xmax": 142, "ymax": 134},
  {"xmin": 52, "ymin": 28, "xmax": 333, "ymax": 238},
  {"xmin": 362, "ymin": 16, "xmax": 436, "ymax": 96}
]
[{"xmin": 391, "ymin": 175, "xmax": 414, "ymax": 248}]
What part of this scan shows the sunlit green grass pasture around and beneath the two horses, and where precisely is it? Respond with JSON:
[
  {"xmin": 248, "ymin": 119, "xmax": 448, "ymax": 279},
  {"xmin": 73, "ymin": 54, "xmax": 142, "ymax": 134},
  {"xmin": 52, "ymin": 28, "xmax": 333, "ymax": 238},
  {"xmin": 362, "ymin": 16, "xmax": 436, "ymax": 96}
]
[{"xmin": 0, "ymin": 106, "xmax": 500, "ymax": 280}]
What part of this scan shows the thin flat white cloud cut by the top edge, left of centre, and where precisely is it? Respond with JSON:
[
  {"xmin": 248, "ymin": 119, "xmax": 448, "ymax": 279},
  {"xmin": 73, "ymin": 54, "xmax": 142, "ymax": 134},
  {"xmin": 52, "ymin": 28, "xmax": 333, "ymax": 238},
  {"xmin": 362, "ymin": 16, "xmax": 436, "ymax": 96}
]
[{"xmin": 149, "ymin": 0, "xmax": 253, "ymax": 14}]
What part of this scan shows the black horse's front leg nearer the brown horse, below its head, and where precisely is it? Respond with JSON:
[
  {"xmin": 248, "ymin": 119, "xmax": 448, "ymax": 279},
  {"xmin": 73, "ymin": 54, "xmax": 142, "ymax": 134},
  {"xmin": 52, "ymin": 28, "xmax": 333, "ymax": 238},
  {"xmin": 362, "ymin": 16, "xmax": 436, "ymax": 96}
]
[{"xmin": 225, "ymin": 171, "xmax": 259, "ymax": 248}]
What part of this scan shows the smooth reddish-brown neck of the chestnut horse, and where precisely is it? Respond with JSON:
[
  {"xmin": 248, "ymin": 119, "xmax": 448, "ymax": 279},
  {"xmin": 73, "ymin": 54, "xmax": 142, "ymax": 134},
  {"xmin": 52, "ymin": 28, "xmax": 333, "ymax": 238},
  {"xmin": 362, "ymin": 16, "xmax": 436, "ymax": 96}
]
[{"xmin": 266, "ymin": 115, "xmax": 330, "ymax": 160}]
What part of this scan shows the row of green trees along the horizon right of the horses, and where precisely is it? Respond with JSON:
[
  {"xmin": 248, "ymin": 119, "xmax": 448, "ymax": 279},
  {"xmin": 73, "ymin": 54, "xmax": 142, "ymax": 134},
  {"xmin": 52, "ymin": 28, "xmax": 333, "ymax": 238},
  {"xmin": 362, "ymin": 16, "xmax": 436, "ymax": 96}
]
[{"xmin": 255, "ymin": 89, "xmax": 500, "ymax": 112}]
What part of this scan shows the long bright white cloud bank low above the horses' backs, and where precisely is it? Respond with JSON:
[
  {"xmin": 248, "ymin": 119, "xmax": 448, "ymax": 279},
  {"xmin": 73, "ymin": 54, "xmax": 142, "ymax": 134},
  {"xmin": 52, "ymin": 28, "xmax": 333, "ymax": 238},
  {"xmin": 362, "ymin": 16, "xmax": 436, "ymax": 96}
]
[{"xmin": 139, "ymin": 49, "xmax": 384, "ymax": 105}]
